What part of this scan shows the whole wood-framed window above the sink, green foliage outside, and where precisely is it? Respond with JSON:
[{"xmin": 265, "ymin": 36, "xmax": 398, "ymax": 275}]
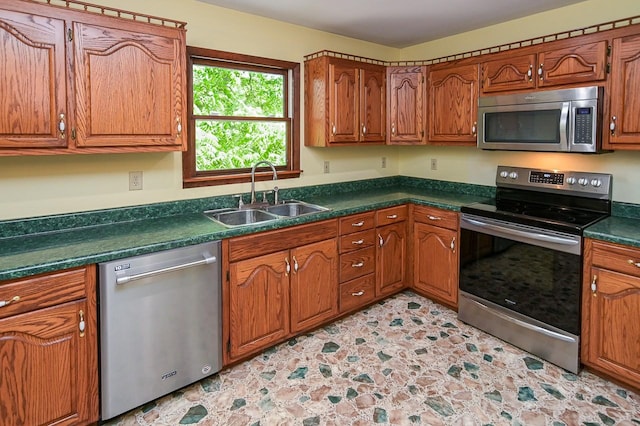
[{"xmin": 182, "ymin": 47, "xmax": 300, "ymax": 188}]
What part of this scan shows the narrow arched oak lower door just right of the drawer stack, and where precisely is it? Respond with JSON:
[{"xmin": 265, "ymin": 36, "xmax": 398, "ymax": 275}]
[{"xmin": 376, "ymin": 222, "xmax": 407, "ymax": 297}]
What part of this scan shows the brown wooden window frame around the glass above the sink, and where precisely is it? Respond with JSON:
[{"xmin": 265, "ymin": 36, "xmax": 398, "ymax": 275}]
[{"xmin": 182, "ymin": 46, "xmax": 302, "ymax": 188}]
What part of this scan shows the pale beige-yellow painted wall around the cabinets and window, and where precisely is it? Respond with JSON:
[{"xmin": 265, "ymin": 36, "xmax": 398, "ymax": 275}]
[{"xmin": 0, "ymin": 0, "xmax": 640, "ymax": 220}]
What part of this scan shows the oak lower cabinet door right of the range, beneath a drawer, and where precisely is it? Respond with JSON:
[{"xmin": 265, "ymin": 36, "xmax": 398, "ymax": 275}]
[{"xmin": 582, "ymin": 267, "xmax": 640, "ymax": 386}]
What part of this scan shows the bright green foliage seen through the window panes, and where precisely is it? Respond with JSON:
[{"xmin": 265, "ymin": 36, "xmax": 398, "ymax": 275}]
[{"xmin": 193, "ymin": 65, "xmax": 288, "ymax": 171}]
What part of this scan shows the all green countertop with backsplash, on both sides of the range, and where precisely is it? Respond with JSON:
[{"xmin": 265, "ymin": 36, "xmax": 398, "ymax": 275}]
[{"xmin": 0, "ymin": 176, "xmax": 640, "ymax": 280}]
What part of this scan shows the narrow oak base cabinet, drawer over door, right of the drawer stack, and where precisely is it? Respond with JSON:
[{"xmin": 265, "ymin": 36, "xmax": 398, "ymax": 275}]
[{"xmin": 376, "ymin": 205, "xmax": 408, "ymax": 297}]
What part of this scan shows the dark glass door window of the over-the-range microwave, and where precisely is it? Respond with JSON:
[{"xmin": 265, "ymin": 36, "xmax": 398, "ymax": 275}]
[{"xmin": 484, "ymin": 109, "xmax": 560, "ymax": 144}]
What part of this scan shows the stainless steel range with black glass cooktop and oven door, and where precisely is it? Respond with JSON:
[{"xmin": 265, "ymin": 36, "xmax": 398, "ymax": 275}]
[{"xmin": 458, "ymin": 166, "xmax": 612, "ymax": 373}]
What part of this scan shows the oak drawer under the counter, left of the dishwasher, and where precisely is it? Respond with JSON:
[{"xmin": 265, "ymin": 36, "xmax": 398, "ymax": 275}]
[{"xmin": 0, "ymin": 268, "xmax": 88, "ymax": 318}]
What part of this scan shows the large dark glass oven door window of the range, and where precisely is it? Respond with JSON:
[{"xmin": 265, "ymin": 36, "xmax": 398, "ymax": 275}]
[{"xmin": 460, "ymin": 229, "xmax": 581, "ymax": 335}]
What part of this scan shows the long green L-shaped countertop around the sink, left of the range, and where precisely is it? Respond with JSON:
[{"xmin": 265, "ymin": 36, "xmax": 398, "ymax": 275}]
[{"xmin": 0, "ymin": 180, "xmax": 490, "ymax": 280}]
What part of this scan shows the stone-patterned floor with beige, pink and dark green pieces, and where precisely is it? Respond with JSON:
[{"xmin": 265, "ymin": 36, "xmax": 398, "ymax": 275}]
[{"xmin": 108, "ymin": 292, "xmax": 640, "ymax": 426}]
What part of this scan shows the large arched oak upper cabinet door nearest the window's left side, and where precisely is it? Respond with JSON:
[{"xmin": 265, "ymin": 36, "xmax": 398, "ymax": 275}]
[{"xmin": 74, "ymin": 23, "xmax": 186, "ymax": 149}]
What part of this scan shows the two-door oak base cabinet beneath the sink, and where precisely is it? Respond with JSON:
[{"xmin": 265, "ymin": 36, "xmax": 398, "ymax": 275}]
[{"xmin": 223, "ymin": 220, "xmax": 338, "ymax": 364}]
